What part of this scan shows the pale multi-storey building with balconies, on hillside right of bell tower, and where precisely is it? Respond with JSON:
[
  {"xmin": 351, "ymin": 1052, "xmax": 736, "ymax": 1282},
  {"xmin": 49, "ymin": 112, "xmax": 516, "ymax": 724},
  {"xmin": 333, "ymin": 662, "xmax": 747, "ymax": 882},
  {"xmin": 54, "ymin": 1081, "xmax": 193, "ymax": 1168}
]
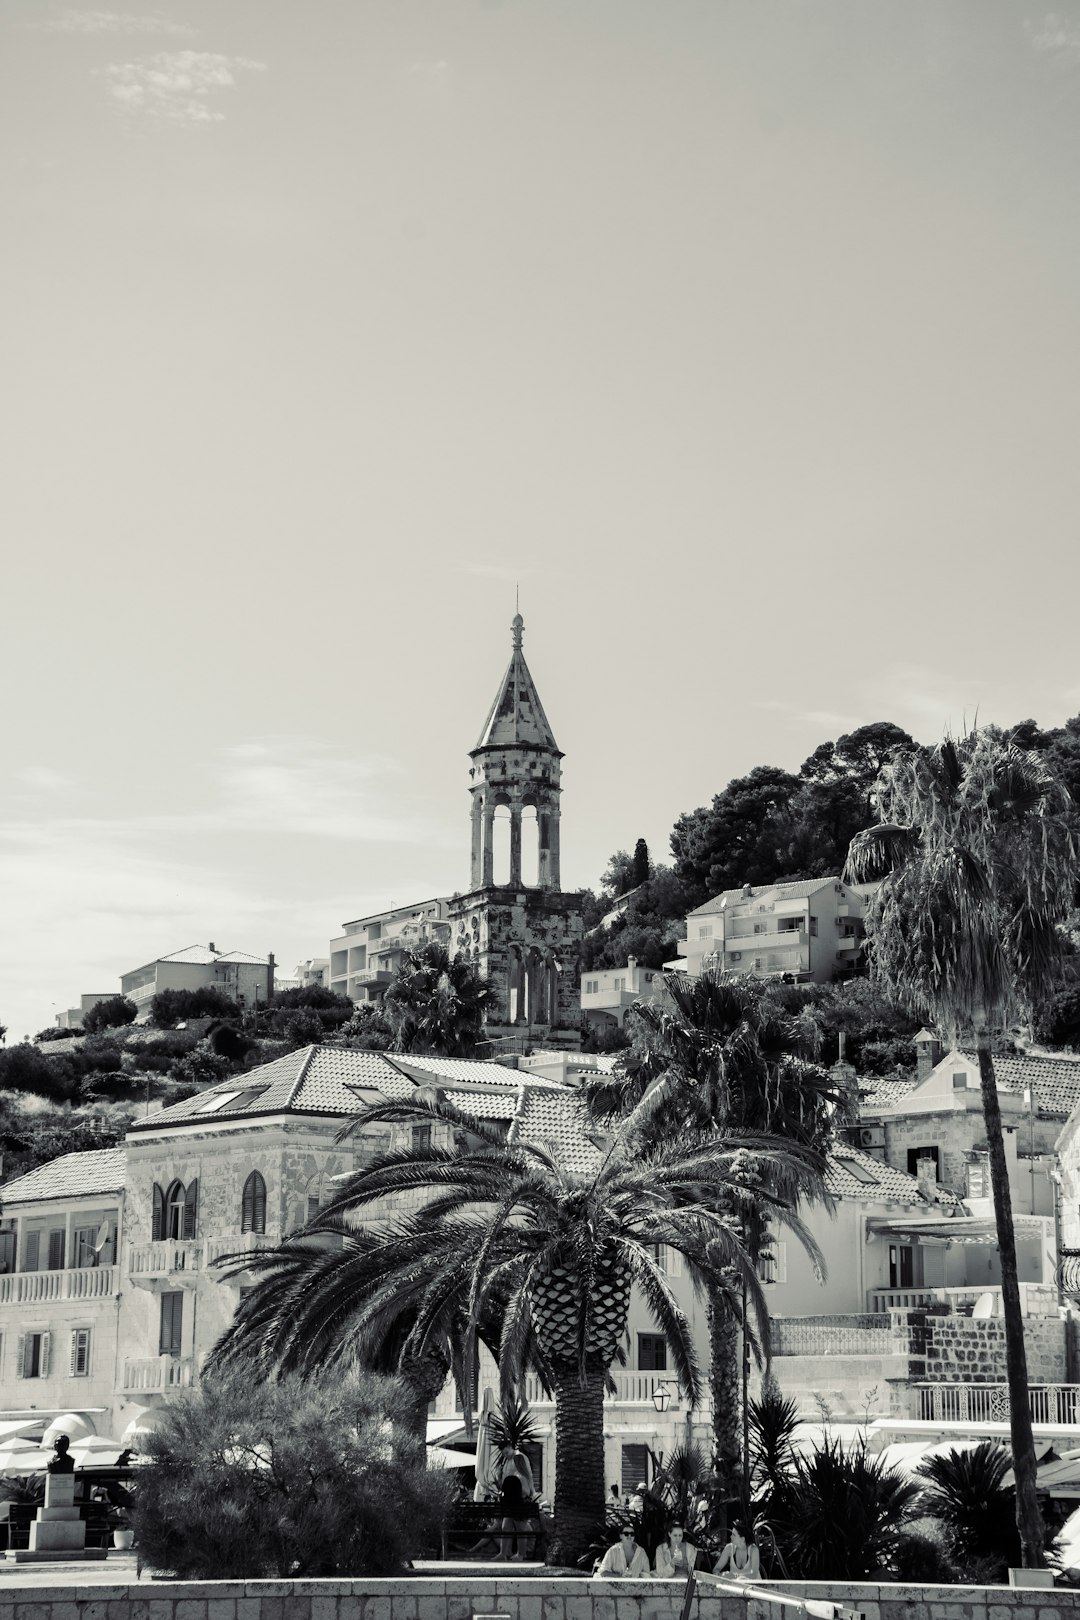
[{"xmin": 676, "ymin": 878, "xmax": 868, "ymax": 983}]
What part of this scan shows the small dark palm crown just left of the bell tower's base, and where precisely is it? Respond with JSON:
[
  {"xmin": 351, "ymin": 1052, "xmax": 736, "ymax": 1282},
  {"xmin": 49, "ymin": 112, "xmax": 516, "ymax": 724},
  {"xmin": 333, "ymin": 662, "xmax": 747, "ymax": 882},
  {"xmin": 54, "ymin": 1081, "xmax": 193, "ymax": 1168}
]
[{"xmin": 382, "ymin": 940, "xmax": 491, "ymax": 1058}]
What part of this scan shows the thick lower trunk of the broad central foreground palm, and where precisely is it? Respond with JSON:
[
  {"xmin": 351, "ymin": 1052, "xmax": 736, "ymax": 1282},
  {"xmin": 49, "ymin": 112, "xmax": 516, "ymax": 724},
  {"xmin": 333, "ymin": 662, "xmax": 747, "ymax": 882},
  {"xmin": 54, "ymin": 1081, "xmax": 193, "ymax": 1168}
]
[{"xmin": 547, "ymin": 1367, "xmax": 607, "ymax": 1567}]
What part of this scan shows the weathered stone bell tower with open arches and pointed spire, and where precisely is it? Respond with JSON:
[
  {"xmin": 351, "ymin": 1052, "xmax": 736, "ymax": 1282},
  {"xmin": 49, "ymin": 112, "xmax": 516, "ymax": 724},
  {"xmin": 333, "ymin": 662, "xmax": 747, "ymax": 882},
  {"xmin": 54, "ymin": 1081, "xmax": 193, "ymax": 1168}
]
[{"xmin": 450, "ymin": 614, "xmax": 583, "ymax": 1050}]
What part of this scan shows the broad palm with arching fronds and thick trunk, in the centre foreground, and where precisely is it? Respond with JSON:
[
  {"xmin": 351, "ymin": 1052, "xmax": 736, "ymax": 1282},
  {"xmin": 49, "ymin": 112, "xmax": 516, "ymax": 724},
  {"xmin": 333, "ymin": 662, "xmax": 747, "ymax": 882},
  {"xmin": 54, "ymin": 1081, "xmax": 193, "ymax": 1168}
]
[{"xmin": 307, "ymin": 1098, "xmax": 822, "ymax": 1563}]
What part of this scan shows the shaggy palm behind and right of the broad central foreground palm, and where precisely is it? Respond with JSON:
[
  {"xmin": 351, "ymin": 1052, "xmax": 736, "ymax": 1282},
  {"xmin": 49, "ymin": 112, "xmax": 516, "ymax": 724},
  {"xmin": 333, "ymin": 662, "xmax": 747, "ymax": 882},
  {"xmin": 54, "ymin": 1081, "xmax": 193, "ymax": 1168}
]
[{"xmin": 588, "ymin": 970, "xmax": 845, "ymax": 1486}]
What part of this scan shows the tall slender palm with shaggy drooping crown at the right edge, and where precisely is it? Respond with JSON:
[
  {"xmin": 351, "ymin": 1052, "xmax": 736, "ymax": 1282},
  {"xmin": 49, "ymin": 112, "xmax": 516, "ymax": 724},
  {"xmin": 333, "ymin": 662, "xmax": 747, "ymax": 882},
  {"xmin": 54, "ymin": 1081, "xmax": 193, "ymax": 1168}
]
[{"xmin": 845, "ymin": 727, "xmax": 1077, "ymax": 1565}]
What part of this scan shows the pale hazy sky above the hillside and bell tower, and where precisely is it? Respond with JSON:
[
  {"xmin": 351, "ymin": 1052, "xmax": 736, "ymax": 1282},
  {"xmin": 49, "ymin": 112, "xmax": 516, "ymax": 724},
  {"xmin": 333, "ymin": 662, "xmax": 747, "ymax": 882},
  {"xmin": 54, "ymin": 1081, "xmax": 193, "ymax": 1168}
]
[{"xmin": 0, "ymin": 0, "xmax": 1080, "ymax": 1042}]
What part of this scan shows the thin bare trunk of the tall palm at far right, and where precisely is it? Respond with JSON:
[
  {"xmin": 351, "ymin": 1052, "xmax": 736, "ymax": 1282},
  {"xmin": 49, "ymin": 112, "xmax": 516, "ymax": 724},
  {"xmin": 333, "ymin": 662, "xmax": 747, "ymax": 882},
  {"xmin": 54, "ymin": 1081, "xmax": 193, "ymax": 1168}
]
[{"xmin": 975, "ymin": 1029, "xmax": 1046, "ymax": 1570}]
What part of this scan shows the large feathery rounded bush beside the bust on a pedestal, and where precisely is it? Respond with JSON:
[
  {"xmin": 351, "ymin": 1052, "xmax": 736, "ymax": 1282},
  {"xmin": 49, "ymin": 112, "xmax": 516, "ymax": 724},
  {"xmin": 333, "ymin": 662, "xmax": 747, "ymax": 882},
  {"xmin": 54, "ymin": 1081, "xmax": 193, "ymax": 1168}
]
[{"xmin": 131, "ymin": 1372, "xmax": 450, "ymax": 1580}]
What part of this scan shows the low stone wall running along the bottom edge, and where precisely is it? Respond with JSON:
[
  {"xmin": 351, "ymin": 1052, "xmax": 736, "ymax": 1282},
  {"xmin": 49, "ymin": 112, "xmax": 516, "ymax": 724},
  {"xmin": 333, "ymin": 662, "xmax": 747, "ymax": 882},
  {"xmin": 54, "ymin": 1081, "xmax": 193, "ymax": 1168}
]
[{"xmin": 0, "ymin": 1575, "xmax": 1080, "ymax": 1620}]
